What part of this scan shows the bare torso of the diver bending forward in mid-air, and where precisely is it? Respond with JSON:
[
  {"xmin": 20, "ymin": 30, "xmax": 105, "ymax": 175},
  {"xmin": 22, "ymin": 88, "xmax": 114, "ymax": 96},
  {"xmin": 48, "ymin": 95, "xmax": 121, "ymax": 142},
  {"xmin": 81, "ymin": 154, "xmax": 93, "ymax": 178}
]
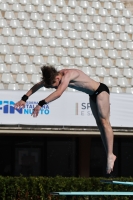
[{"xmin": 60, "ymin": 69, "xmax": 100, "ymax": 95}]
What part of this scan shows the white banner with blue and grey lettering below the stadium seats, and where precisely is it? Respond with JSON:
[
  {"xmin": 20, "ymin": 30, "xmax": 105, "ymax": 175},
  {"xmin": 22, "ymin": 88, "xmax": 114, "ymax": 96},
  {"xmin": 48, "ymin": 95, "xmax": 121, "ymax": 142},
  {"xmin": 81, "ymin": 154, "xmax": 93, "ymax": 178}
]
[{"xmin": 0, "ymin": 90, "xmax": 133, "ymax": 127}]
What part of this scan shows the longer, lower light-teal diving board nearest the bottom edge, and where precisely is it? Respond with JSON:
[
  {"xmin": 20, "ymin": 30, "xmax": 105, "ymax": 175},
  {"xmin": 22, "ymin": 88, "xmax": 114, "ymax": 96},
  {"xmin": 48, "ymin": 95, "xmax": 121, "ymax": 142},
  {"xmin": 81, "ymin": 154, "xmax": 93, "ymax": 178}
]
[{"xmin": 50, "ymin": 191, "xmax": 133, "ymax": 196}]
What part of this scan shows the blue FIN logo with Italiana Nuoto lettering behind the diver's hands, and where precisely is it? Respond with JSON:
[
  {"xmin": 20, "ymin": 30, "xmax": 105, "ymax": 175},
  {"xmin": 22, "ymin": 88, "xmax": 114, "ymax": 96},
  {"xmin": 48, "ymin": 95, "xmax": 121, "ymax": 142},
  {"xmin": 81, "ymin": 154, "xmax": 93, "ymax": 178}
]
[{"xmin": 0, "ymin": 100, "xmax": 50, "ymax": 115}]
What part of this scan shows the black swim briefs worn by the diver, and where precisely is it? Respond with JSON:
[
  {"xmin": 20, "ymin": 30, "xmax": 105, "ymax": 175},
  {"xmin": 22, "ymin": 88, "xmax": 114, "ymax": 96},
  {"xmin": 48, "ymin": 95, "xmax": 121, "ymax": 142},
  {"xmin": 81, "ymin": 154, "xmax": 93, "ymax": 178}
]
[{"xmin": 89, "ymin": 83, "xmax": 110, "ymax": 102}]
